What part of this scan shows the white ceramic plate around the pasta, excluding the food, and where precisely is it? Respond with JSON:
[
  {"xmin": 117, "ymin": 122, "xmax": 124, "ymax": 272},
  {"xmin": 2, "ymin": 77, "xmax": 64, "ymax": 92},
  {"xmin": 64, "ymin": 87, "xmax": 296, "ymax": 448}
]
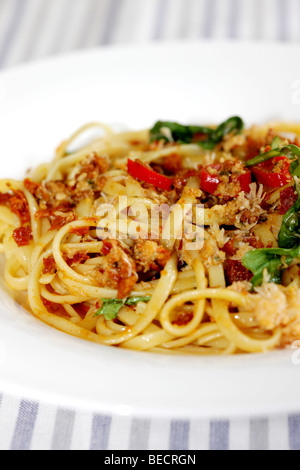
[{"xmin": 0, "ymin": 43, "xmax": 300, "ymax": 418}]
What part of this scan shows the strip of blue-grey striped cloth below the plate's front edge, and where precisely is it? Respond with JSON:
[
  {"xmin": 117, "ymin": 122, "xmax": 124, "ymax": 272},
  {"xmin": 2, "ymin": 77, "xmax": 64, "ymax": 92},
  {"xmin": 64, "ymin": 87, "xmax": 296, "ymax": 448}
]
[{"xmin": 0, "ymin": 396, "xmax": 300, "ymax": 451}]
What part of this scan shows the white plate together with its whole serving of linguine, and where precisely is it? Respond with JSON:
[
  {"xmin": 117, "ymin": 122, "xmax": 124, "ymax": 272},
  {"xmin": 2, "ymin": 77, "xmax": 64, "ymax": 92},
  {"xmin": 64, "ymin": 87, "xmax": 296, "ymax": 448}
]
[{"xmin": 0, "ymin": 39, "xmax": 300, "ymax": 417}]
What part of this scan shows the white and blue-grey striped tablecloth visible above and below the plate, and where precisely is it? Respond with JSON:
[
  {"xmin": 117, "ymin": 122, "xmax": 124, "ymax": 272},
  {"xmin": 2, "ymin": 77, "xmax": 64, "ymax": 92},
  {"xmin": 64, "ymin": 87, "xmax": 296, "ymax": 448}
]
[{"xmin": 0, "ymin": 0, "xmax": 300, "ymax": 451}]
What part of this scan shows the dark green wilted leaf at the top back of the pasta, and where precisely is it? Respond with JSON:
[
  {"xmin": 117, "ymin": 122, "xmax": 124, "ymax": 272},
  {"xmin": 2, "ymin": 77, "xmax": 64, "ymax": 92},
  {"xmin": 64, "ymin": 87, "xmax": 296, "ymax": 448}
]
[{"xmin": 150, "ymin": 116, "xmax": 244, "ymax": 150}]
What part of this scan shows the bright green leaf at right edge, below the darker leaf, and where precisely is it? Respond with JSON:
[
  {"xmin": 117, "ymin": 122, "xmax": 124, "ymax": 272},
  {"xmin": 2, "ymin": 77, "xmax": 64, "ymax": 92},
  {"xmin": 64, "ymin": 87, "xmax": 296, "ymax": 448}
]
[{"xmin": 242, "ymin": 245, "xmax": 300, "ymax": 287}]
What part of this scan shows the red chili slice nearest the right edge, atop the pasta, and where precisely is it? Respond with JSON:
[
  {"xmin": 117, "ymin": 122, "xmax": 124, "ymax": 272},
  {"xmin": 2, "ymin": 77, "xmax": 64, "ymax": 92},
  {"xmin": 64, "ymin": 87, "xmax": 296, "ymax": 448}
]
[{"xmin": 251, "ymin": 156, "xmax": 293, "ymax": 188}]
